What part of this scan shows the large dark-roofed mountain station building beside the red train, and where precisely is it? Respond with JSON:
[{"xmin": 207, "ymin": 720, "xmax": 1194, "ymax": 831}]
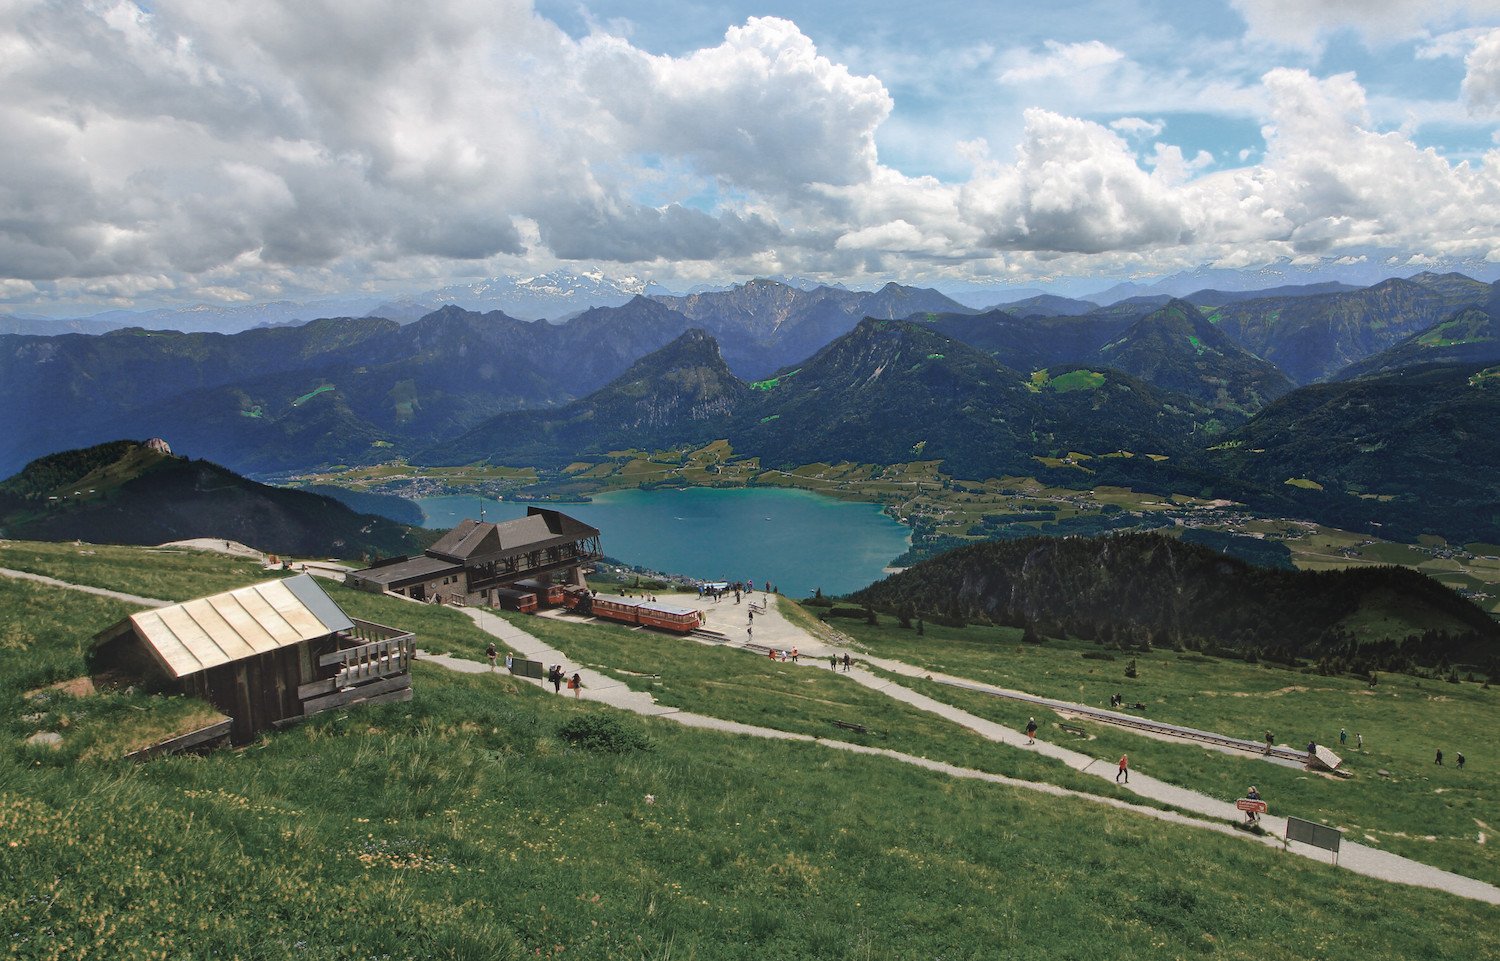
[{"xmin": 344, "ymin": 507, "xmax": 602, "ymax": 607}]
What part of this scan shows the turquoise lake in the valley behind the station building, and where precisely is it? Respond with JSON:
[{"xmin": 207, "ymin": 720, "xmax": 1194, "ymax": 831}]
[{"xmin": 417, "ymin": 487, "xmax": 911, "ymax": 597}]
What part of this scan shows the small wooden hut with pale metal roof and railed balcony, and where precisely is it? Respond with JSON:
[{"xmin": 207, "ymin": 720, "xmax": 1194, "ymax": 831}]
[{"xmin": 90, "ymin": 574, "xmax": 413, "ymax": 744}]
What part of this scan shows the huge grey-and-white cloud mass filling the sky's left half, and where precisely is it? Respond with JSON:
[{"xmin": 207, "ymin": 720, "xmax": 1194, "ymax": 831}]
[{"xmin": 0, "ymin": 0, "xmax": 891, "ymax": 299}]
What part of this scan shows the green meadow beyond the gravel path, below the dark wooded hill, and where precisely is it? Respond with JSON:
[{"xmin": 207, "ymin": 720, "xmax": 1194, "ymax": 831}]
[{"xmin": 839, "ymin": 616, "xmax": 1500, "ymax": 883}]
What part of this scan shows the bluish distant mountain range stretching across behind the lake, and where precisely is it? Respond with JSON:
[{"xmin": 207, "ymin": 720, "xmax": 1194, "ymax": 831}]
[{"xmin": 0, "ymin": 274, "xmax": 1500, "ymax": 545}]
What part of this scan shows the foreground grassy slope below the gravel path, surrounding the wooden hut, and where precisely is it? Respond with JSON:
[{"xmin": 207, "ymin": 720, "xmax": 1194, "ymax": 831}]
[{"xmin": 0, "ymin": 542, "xmax": 1500, "ymax": 961}]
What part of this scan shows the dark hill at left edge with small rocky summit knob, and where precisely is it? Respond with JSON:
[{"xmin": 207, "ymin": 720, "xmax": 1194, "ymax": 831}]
[{"xmin": 0, "ymin": 441, "xmax": 431, "ymax": 558}]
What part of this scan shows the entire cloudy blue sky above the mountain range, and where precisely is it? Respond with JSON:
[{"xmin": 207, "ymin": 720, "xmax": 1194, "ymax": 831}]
[{"xmin": 0, "ymin": 0, "xmax": 1500, "ymax": 312}]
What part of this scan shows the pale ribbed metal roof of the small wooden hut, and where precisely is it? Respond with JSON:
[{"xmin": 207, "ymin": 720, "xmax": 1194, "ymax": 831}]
[{"xmin": 99, "ymin": 574, "xmax": 354, "ymax": 678}]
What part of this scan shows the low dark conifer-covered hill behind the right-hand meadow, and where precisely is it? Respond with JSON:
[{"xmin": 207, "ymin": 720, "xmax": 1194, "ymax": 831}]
[{"xmin": 852, "ymin": 534, "xmax": 1500, "ymax": 675}]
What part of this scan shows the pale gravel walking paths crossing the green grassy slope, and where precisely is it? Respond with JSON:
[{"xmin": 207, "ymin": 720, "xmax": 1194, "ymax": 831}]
[{"xmin": 11, "ymin": 568, "xmax": 1500, "ymax": 904}]
